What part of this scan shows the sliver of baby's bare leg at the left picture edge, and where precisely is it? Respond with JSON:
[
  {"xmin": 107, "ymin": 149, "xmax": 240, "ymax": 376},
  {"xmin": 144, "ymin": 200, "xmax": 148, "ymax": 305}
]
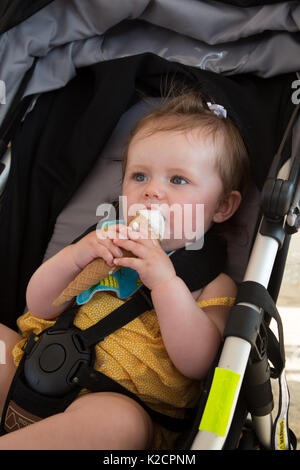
[{"xmin": 0, "ymin": 324, "xmax": 22, "ymax": 414}]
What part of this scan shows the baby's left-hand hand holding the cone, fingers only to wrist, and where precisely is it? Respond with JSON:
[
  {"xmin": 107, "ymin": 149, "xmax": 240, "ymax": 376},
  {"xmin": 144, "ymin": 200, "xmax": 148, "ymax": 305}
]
[{"xmin": 71, "ymin": 225, "xmax": 122, "ymax": 269}]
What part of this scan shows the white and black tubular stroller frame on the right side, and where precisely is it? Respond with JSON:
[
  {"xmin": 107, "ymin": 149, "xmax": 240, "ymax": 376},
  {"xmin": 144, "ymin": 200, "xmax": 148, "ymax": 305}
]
[{"xmin": 191, "ymin": 105, "xmax": 300, "ymax": 450}]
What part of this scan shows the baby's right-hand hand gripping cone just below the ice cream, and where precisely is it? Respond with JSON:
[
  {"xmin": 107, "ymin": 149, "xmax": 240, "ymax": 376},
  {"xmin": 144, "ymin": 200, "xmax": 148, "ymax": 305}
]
[{"xmin": 113, "ymin": 226, "xmax": 176, "ymax": 290}]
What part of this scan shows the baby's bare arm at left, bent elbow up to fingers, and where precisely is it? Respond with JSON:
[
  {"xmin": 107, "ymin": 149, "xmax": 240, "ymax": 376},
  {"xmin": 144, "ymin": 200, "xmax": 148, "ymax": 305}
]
[{"xmin": 26, "ymin": 225, "xmax": 122, "ymax": 320}]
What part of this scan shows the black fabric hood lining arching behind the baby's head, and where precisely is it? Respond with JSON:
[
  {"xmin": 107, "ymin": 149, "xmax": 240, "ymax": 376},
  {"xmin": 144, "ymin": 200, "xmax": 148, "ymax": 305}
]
[{"xmin": 0, "ymin": 54, "xmax": 295, "ymax": 328}]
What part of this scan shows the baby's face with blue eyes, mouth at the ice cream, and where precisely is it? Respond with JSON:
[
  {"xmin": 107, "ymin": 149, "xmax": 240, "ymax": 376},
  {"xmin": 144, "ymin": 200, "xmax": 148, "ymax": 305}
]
[{"xmin": 123, "ymin": 125, "xmax": 223, "ymax": 250}]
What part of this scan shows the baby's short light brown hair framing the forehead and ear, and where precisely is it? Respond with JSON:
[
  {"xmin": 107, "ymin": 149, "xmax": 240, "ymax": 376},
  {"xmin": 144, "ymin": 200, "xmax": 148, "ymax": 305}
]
[{"xmin": 123, "ymin": 89, "xmax": 249, "ymax": 194}]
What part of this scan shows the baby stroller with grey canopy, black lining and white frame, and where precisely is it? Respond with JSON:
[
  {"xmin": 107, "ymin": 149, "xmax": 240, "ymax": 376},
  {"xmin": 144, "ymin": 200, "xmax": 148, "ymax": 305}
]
[{"xmin": 0, "ymin": 0, "xmax": 300, "ymax": 450}]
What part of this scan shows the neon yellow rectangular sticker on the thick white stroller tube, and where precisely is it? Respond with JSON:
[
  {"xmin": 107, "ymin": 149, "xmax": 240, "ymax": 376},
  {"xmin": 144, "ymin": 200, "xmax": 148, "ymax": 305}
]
[{"xmin": 199, "ymin": 367, "xmax": 240, "ymax": 437}]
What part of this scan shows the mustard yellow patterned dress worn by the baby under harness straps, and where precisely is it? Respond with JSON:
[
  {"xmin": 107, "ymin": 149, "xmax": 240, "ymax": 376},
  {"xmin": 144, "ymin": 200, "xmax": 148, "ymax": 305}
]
[{"xmin": 13, "ymin": 291, "xmax": 234, "ymax": 449}]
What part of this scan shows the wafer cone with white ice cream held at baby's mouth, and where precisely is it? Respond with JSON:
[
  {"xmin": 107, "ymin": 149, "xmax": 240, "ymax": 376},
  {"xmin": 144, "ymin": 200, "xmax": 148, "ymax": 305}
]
[{"xmin": 53, "ymin": 210, "xmax": 164, "ymax": 307}]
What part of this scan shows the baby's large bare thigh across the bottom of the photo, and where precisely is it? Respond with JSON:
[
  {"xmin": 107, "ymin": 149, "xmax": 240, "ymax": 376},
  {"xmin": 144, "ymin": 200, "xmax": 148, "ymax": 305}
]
[{"xmin": 0, "ymin": 392, "xmax": 152, "ymax": 450}]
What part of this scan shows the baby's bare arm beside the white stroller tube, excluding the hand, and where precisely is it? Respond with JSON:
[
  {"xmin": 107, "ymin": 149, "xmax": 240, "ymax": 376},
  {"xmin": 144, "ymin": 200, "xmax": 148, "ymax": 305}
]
[{"xmin": 152, "ymin": 274, "xmax": 236, "ymax": 379}]
